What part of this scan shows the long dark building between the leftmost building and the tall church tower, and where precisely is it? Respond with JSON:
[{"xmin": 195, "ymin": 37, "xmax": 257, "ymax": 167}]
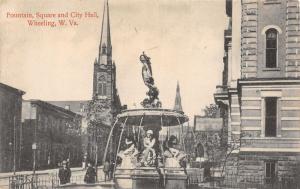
[{"xmin": 21, "ymin": 100, "xmax": 83, "ymax": 170}]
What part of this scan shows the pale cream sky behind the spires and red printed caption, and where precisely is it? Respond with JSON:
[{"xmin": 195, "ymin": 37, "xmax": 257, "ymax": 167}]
[{"xmin": 0, "ymin": 0, "xmax": 228, "ymax": 123}]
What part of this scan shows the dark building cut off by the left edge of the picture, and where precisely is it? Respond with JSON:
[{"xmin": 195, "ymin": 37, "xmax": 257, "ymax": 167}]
[{"xmin": 0, "ymin": 83, "xmax": 25, "ymax": 172}]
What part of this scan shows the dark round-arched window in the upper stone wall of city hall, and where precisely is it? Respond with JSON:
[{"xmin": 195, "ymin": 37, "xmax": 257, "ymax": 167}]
[{"xmin": 266, "ymin": 28, "xmax": 278, "ymax": 68}]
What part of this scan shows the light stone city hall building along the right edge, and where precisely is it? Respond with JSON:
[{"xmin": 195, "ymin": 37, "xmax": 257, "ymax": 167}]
[{"xmin": 215, "ymin": 0, "xmax": 300, "ymax": 182}]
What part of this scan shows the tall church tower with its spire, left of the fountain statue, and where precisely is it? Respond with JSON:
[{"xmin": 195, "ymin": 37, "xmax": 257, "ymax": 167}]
[{"xmin": 92, "ymin": 2, "xmax": 121, "ymax": 123}]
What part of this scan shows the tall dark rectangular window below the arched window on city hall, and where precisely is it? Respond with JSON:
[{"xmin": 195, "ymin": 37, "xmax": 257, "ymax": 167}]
[{"xmin": 265, "ymin": 97, "xmax": 277, "ymax": 137}]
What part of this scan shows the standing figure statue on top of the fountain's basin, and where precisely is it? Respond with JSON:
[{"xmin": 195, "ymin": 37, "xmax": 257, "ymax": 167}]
[{"xmin": 140, "ymin": 52, "xmax": 161, "ymax": 108}]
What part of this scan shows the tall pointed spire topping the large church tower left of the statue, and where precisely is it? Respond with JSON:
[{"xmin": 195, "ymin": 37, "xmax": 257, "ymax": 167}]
[{"xmin": 99, "ymin": 0, "xmax": 112, "ymax": 64}]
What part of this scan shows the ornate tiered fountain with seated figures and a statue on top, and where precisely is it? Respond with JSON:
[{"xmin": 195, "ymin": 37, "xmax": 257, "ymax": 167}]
[{"xmin": 104, "ymin": 53, "xmax": 188, "ymax": 189}]
